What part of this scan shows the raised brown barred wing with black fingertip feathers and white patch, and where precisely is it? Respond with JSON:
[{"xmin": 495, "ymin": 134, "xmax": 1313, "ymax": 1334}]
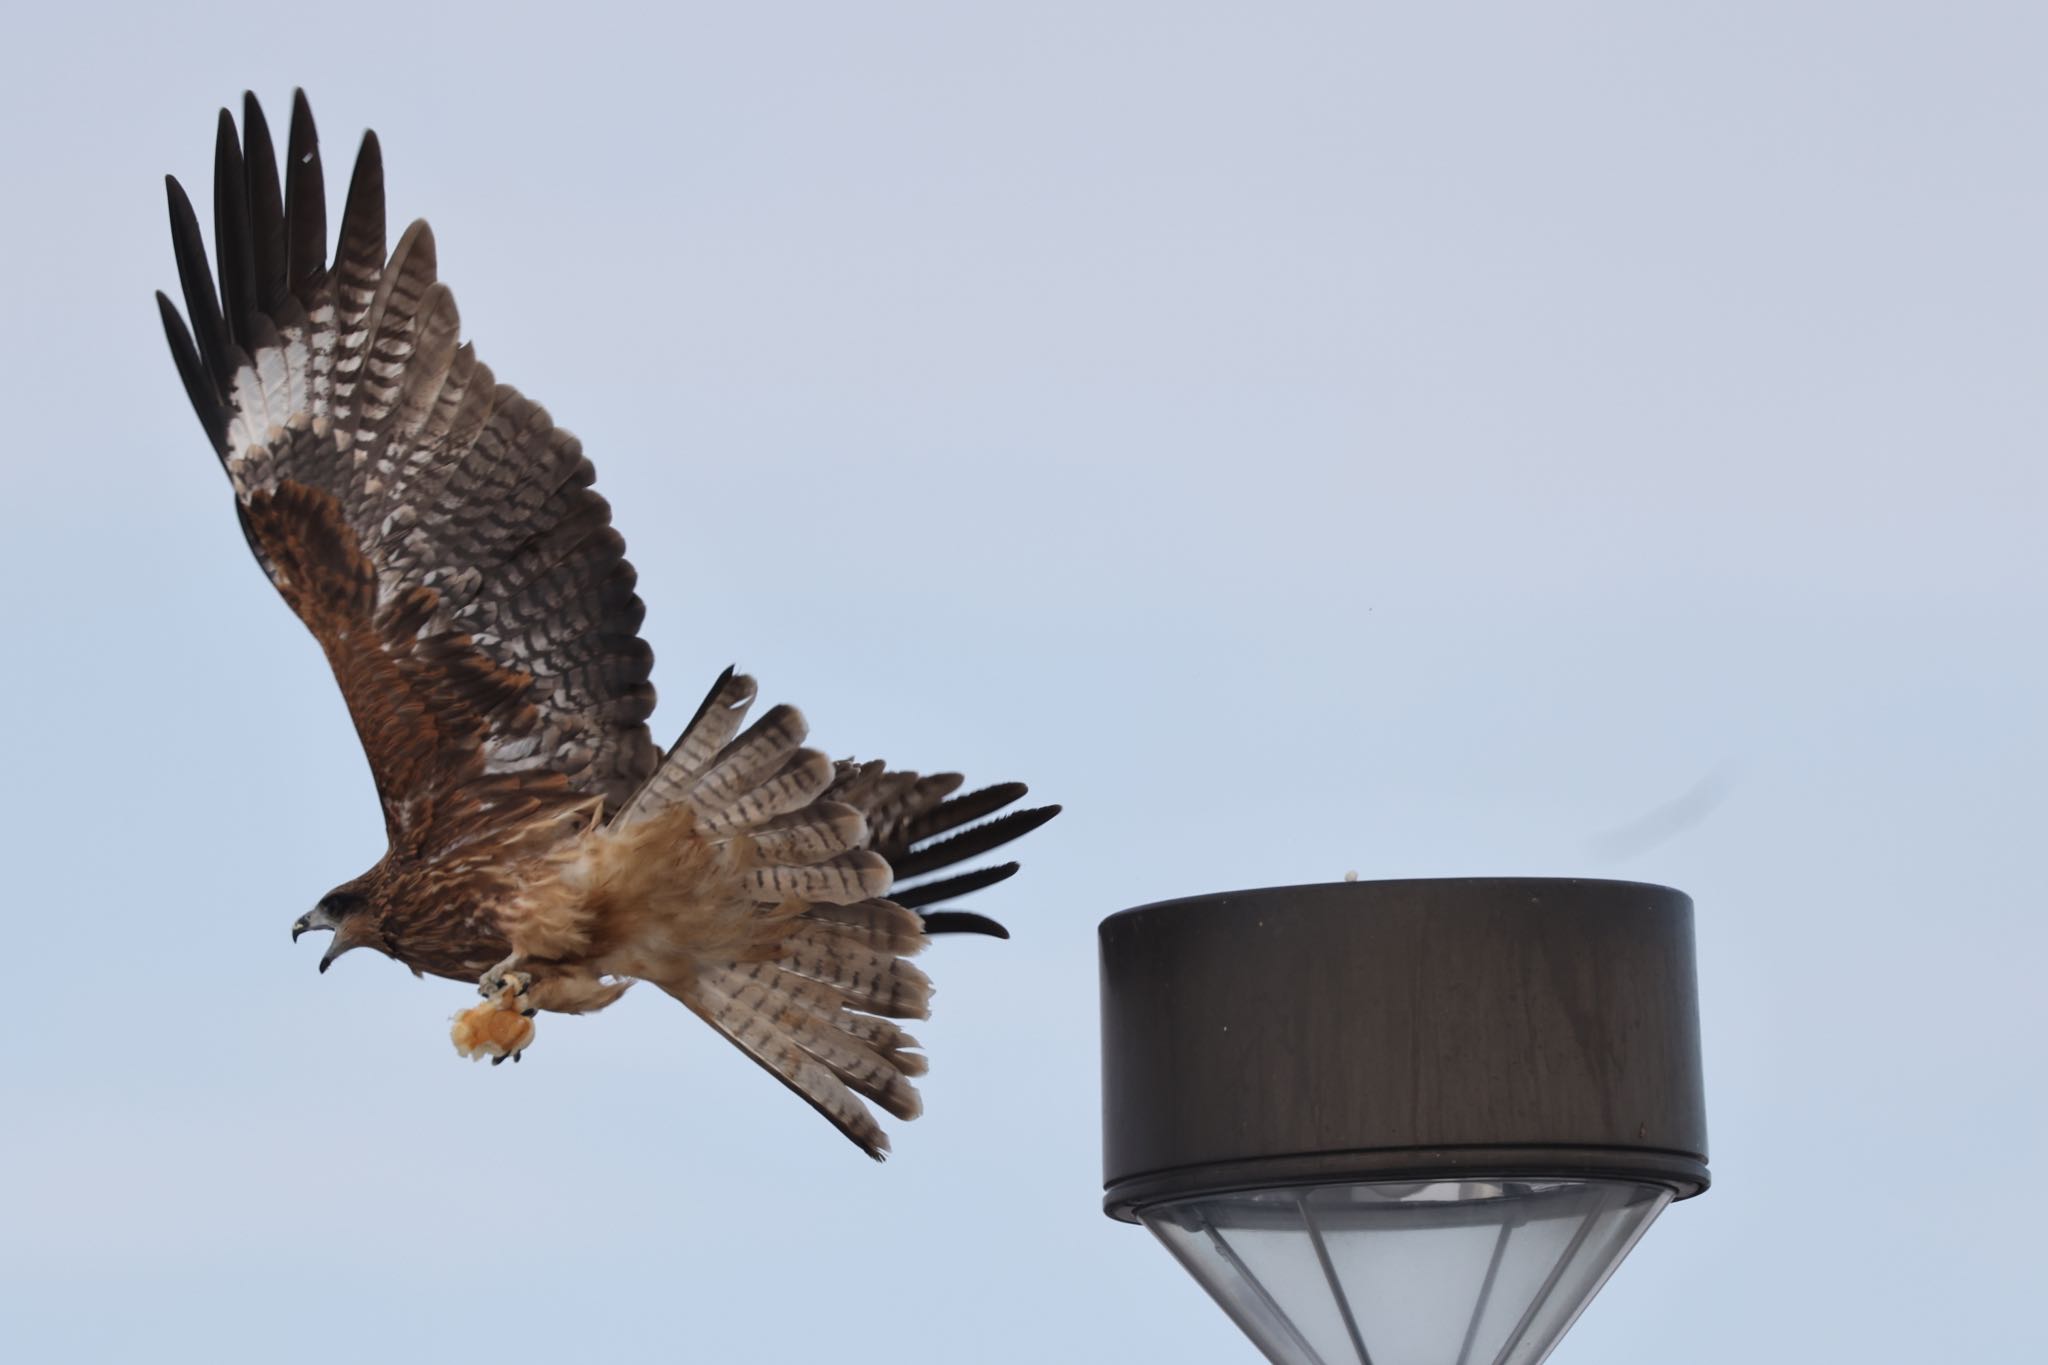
[{"xmin": 158, "ymin": 92, "xmax": 659, "ymax": 845}]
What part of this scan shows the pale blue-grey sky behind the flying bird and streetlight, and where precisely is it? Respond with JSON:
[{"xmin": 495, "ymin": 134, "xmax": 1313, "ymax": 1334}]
[{"xmin": 0, "ymin": 0, "xmax": 2048, "ymax": 1365}]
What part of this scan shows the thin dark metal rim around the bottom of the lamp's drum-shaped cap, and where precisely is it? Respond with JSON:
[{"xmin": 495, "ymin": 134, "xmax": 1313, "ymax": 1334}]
[{"xmin": 1102, "ymin": 1146, "xmax": 1710, "ymax": 1224}]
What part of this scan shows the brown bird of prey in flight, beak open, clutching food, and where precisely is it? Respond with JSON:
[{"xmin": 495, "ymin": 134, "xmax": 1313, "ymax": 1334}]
[{"xmin": 158, "ymin": 92, "xmax": 1059, "ymax": 1158}]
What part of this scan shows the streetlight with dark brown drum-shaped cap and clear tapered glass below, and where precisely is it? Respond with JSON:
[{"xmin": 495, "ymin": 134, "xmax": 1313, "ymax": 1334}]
[{"xmin": 1102, "ymin": 878, "xmax": 1708, "ymax": 1365}]
